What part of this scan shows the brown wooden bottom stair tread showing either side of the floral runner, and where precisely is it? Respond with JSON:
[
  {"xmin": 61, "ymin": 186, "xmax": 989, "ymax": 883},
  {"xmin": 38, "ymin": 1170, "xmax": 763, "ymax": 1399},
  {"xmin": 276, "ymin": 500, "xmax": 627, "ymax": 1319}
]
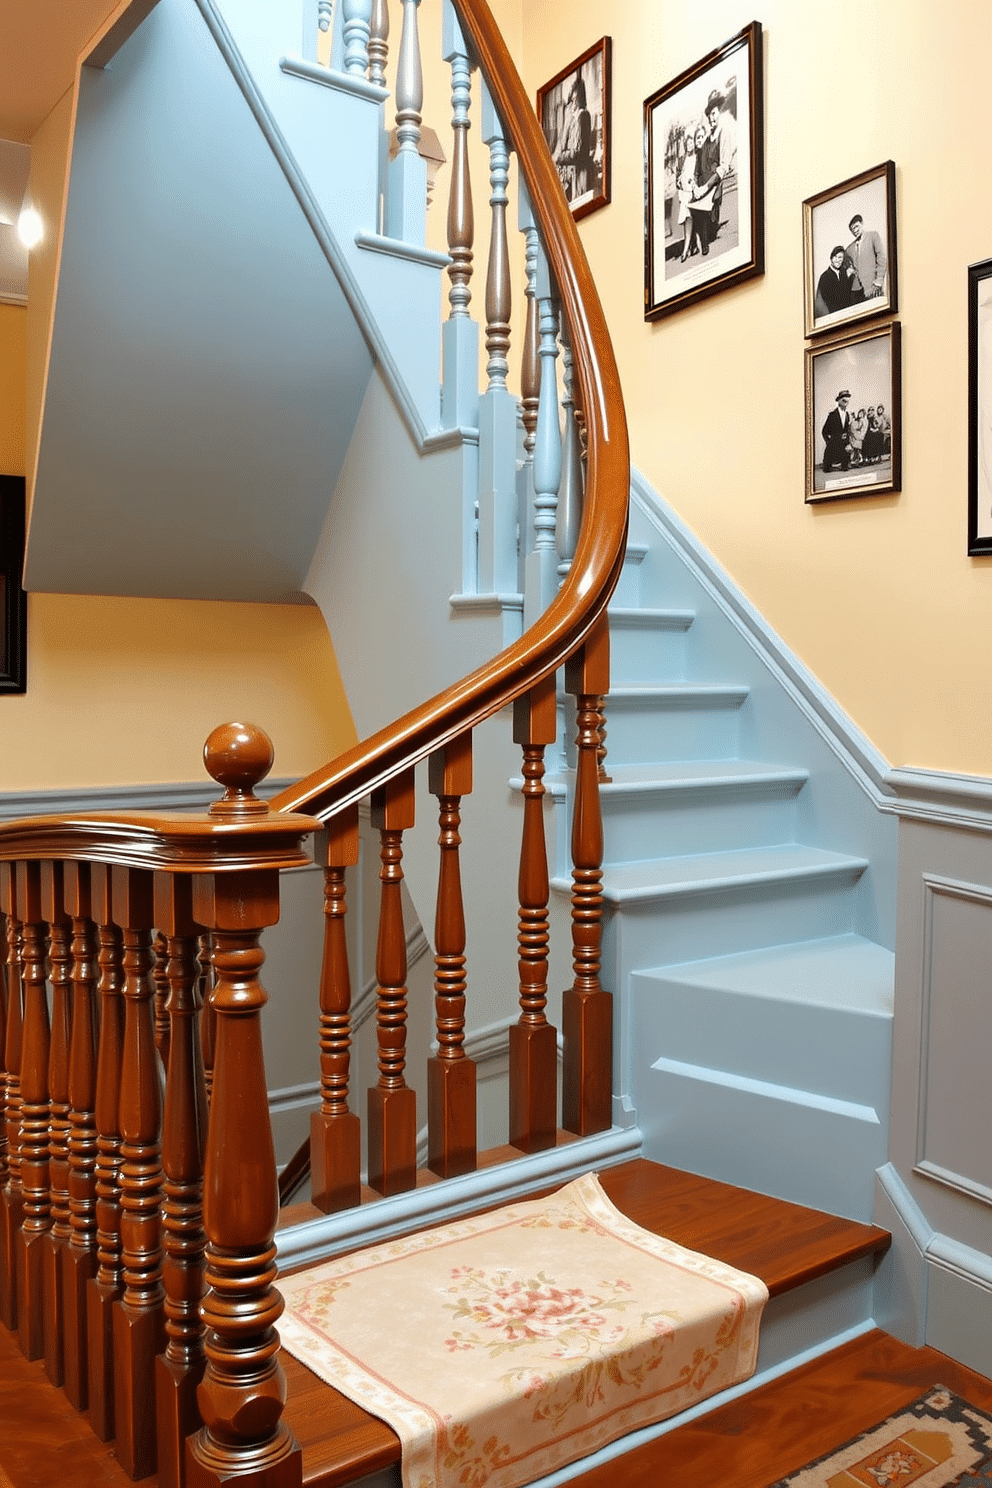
[{"xmin": 283, "ymin": 1158, "xmax": 889, "ymax": 1488}]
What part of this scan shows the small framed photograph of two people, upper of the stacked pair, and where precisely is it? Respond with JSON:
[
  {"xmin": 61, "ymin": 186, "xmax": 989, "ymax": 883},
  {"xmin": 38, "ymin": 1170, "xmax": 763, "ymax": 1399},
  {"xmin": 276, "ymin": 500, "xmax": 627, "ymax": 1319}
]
[{"xmin": 803, "ymin": 161, "xmax": 898, "ymax": 336}]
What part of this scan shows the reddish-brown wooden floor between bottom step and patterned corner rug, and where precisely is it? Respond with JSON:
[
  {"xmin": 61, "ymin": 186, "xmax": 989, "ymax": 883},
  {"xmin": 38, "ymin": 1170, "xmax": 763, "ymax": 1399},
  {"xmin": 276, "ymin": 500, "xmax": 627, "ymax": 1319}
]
[{"xmin": 573, "ymin": 1329, "xmax": 992, "ymax": 1488}]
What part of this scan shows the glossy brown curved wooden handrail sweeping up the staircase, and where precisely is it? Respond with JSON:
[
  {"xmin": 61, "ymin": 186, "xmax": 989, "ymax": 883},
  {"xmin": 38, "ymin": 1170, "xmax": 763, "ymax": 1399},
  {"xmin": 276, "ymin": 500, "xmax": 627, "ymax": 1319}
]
[{"xmin": 271, "ymin": 0, "xmax": 631, "ymax": 820}]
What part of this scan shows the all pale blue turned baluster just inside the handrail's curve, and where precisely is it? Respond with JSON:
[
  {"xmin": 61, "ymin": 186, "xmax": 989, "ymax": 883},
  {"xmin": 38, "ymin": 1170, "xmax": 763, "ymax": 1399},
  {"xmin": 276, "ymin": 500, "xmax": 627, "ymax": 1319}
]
[{"xmin": 524, "ymin": 244, "xmax": 562, "ymax": 625}]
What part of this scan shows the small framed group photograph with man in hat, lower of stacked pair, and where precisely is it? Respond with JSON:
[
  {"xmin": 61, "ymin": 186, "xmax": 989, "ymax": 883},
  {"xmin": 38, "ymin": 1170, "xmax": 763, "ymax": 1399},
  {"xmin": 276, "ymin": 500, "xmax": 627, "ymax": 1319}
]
[{"xmin": 806, "ymin": 321, "xmax": 903, "ymax": 501}]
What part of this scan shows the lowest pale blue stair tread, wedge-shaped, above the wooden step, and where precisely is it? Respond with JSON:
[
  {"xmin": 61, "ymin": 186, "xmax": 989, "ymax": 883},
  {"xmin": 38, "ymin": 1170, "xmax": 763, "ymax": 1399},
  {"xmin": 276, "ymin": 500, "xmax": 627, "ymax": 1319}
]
[{"xmin": 634, "ymin": 933, "xmax": 895, "ymax": 1018}]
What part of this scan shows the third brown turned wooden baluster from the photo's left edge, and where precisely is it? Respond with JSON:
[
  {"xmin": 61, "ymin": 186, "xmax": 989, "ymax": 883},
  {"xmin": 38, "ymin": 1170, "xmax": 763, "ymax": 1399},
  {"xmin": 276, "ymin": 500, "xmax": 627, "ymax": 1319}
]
[{"xmin": 42, "ymin": 862, "xmax": 73, "ymax": 1385}]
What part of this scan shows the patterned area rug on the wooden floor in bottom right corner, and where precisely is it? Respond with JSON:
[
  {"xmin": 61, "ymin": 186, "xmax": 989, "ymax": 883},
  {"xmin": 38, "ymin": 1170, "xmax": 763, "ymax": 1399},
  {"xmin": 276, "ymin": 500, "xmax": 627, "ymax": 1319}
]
[{"xmin": 772, "ymin": 1385, "xmax": 992, "ymax": 1488}]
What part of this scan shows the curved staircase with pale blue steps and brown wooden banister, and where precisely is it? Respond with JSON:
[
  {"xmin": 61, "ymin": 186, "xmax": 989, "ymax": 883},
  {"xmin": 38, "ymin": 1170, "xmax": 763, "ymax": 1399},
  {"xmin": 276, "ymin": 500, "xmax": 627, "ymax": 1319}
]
[{"xmin": 0, "ymin": 0, "xmax": 933, "ymax": 1488}]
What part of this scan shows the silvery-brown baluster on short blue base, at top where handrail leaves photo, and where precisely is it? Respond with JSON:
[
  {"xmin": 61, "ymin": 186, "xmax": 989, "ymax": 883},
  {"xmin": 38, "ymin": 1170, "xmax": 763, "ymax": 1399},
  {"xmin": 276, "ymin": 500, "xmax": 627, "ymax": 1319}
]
[{"xmin": 442, "ymin": 0, "xmax": 479, "ymax": 429}]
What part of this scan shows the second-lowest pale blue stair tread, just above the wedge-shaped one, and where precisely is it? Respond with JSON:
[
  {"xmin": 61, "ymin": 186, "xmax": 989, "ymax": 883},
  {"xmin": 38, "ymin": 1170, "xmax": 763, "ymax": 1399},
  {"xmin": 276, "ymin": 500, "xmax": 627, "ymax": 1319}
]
[{"xmin": 594, "ymin": 842, "xmax": 869, "ymax": 903}]
